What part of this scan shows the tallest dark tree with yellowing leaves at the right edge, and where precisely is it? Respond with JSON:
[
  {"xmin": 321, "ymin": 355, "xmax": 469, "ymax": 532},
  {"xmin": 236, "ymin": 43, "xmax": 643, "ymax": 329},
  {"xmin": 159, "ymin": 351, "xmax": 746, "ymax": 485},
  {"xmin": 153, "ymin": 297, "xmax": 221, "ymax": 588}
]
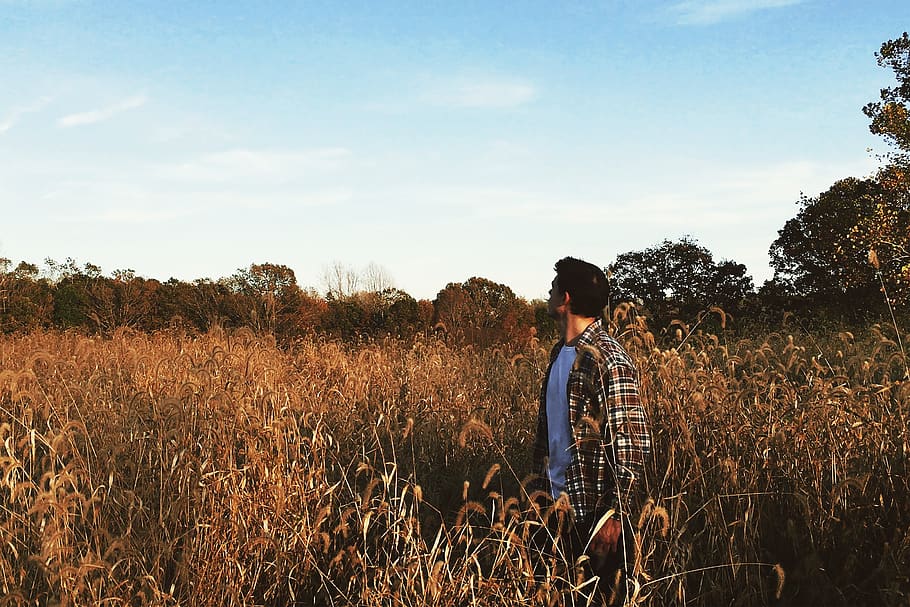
[{"xmin": 767, "ymin": 33, "xmax": 910, "ymax": 320}]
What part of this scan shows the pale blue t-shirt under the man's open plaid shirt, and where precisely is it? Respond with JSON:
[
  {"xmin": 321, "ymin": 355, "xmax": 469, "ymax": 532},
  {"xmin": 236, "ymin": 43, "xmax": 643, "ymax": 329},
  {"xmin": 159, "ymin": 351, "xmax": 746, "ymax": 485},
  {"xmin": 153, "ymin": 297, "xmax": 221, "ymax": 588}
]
[{"xmin": 547, "ymin": 346, "xmax": 575, "ymax": 499}]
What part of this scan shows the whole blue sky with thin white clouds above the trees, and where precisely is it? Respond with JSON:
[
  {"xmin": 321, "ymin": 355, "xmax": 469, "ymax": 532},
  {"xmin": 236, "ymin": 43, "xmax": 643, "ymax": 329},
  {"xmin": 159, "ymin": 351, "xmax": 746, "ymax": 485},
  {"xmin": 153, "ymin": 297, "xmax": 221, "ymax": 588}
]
[{"xmin": 0, "ymin": 0, "xmax": 910, "ymax": 299}]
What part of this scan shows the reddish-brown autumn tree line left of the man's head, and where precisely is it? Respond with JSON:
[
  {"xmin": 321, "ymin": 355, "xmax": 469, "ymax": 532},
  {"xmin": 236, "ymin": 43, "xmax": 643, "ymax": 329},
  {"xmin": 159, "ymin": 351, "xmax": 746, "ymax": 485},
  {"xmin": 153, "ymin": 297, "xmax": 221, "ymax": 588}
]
[{"xmin": 0, "ymin": 258, "xmax": 546, "ymax": 346}]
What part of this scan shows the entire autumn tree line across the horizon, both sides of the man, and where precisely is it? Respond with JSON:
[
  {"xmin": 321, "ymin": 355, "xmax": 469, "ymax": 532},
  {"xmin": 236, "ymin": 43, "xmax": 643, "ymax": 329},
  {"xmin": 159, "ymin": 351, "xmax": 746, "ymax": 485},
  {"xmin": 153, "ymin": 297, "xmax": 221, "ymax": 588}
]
[{"xmin": 0, "ymin": 32, "xmax": 910, "ymax": 347}]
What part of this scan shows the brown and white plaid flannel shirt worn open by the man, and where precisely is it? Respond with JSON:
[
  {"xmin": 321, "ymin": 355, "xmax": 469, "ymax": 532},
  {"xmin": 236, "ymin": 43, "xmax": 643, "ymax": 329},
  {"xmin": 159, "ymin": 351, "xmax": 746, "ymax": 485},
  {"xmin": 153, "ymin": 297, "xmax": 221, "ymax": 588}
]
[{"xmin": 533, "ymin": 319, "xmax": 651, "ymax": 522}]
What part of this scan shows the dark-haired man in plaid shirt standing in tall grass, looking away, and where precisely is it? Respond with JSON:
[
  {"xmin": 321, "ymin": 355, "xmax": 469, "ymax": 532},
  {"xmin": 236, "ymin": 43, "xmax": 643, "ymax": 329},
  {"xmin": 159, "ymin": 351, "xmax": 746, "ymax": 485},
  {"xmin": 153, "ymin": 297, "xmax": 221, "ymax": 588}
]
[{"xmin": 534, "ymin": 257, "xmax": 651, "ymax": 577}]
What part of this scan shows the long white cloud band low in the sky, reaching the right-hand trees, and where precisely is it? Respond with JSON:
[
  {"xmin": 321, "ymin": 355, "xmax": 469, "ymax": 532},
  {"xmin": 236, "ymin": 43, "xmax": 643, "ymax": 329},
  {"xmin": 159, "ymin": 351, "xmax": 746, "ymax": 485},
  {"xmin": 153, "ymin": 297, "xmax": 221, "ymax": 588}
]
[{"xmin": 395, "ymin": 159, "xmax": 875, "ymax": 229}]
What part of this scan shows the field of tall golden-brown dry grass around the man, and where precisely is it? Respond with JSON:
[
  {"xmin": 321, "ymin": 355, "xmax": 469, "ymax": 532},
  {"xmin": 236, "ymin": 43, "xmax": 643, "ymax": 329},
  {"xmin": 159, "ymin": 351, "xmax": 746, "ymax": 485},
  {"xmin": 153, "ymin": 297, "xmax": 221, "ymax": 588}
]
[{"xmin": 0, "ymin": 319, "xmax": 910, "ymax": 606}]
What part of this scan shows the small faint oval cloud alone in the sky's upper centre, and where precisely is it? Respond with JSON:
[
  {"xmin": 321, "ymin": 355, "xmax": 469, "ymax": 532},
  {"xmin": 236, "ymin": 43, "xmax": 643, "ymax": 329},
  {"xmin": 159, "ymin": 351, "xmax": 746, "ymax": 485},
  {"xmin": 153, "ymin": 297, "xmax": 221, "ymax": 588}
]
[{"xmin": 420, "ymin": 77, "xmax": 538, "ymax": 108}]
